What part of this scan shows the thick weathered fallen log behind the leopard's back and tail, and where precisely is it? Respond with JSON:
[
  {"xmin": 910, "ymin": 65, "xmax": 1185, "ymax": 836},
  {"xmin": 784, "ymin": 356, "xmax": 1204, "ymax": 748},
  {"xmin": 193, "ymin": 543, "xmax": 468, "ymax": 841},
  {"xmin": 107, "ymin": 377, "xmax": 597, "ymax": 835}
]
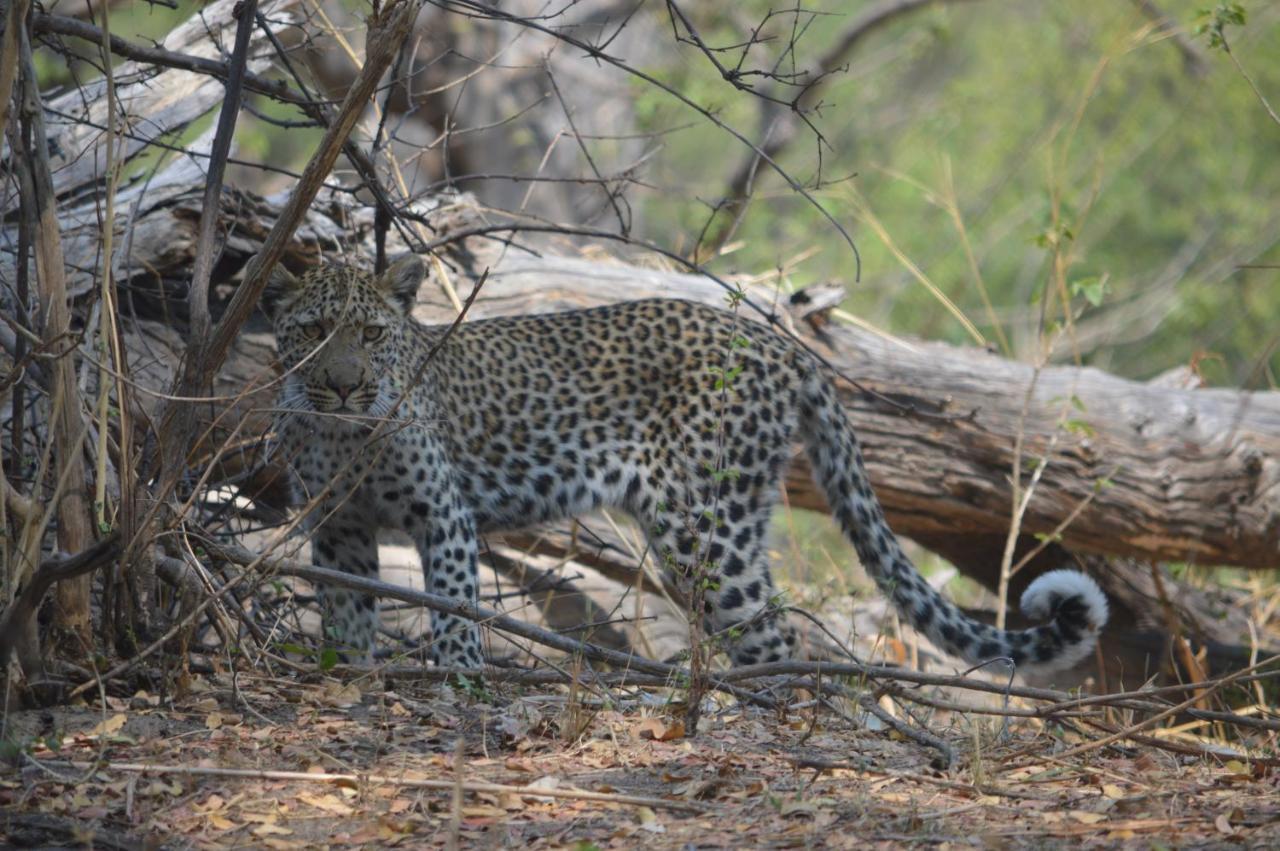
[{"xmin": 407, "ymin": 252, "xmax": 1280, "ymax": 568}]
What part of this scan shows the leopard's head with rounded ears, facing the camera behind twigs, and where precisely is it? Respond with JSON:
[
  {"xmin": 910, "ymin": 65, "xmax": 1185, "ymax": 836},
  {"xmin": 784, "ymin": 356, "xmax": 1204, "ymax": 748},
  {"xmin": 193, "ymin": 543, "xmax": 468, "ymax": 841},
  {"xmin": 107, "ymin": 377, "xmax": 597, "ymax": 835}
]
[{"xmin": 253, "ymin": 255, "xmax": 426, "ymax": 417}]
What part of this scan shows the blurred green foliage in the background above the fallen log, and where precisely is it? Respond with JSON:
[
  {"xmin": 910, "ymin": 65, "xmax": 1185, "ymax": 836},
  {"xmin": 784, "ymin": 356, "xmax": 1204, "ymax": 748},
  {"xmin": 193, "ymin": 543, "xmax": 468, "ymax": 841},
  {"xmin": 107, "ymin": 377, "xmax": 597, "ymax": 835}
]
[{"xmin": 639, "ymin": 0, "xmax": 1280, "ymax": 389}]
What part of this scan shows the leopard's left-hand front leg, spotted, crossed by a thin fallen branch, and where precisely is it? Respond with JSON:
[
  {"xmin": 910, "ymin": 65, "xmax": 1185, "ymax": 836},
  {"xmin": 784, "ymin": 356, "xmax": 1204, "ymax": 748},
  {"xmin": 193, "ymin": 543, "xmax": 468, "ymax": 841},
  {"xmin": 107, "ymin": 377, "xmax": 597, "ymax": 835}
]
[{"xmin": 311, "ymin": 511, "xmax": 378, "ymax": 663}]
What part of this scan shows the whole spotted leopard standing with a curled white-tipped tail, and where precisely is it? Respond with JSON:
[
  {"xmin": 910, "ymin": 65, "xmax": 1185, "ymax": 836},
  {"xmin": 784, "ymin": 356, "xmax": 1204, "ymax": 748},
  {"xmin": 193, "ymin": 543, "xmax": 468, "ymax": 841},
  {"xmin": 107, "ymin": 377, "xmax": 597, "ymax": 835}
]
[{"xmin": 255, "ymin": 253, "xmax": 1107, "ymax": 673}]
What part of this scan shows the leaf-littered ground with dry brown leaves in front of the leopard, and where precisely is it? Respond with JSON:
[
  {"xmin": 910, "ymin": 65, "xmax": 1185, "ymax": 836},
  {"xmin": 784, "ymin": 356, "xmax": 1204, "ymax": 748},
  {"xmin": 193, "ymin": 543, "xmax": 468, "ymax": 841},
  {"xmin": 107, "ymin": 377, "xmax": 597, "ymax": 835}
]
[{"xmin": 0, "ymin": 672, "xmax": 1280, "ymax": 851}]
